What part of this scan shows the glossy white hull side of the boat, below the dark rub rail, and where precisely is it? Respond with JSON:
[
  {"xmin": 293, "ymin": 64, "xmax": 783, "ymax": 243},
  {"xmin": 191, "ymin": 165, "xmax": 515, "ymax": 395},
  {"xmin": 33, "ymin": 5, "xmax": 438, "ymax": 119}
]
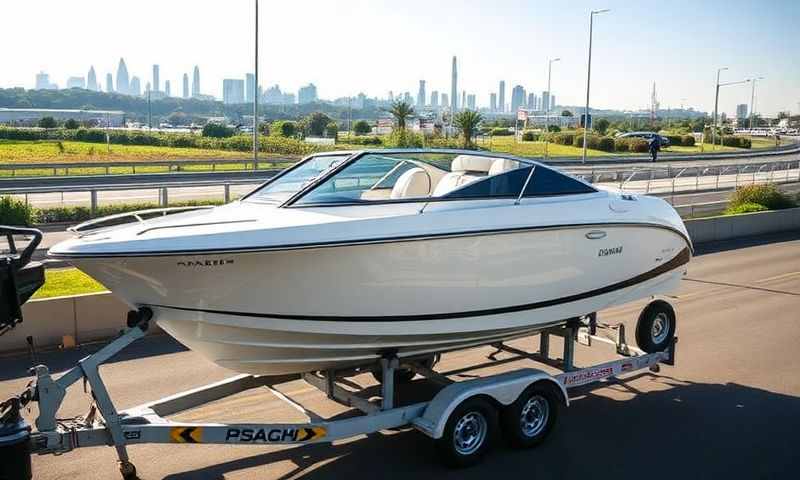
[{"xmin": 73, "ymin": 224, "xmax": 690, "ymax": 375}]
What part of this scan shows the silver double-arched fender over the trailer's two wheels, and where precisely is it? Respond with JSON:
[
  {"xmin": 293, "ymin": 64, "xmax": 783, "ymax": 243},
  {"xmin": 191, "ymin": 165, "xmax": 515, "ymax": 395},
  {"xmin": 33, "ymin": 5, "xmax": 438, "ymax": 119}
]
[{"xmin": 411, "ymin": 368, "xmax": 569, "ymax": 439}]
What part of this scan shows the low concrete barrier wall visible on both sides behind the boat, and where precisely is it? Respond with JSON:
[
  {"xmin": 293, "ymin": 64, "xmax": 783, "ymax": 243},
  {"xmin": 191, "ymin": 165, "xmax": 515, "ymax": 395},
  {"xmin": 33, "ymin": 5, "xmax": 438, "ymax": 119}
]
[{"xmin": 0, "ymin": 208, "xmax": 800, "ymax": 352}]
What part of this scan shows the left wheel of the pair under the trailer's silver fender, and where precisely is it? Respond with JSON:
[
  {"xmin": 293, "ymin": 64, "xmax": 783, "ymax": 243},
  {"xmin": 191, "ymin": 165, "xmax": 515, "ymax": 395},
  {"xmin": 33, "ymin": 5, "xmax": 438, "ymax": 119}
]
[{"xmin": 436, "ymin": 397, "xmax": 497, "ymax": 468}]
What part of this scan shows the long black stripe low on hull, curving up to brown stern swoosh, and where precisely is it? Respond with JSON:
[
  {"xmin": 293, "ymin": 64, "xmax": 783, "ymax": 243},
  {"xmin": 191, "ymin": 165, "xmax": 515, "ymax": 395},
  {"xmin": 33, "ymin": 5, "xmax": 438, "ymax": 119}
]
[{"xmin": 152, "ymin": 248, "xmax": 691, "ymax": 322}]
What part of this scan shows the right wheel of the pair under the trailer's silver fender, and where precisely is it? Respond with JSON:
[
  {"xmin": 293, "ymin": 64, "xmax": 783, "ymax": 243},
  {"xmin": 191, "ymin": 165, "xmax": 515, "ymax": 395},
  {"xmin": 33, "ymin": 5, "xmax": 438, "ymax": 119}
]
[{"xmin": 500, "ymin": 381, "xmax": 562, "ymax": 448}]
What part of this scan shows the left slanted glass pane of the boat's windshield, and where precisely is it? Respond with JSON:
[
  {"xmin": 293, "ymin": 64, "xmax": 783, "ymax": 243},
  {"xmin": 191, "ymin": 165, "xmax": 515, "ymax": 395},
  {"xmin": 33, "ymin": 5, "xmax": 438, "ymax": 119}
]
[{"xmin": 247, "ymin": 153, "xmax": 349, "ymax": 203}]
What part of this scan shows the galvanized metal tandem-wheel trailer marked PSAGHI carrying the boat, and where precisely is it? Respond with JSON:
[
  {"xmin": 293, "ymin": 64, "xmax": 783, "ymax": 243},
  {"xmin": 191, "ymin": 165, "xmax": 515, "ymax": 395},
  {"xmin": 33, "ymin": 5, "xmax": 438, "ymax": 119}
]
[{"xmin": 0, "ymin": 300, "xmax": 677, "ymax": 480}]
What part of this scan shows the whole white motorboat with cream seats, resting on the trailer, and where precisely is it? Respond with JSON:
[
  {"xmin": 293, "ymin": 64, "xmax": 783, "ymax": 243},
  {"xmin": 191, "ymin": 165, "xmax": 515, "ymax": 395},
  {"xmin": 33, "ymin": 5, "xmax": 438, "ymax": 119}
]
[{"xmin": 49, "ymin": 150, "xmax": 692, "ymax": 375}]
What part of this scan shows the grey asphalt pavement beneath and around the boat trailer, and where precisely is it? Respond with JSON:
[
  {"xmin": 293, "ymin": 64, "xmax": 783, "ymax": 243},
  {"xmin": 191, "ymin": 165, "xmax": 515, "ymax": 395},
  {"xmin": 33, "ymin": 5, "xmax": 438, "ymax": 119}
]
[{"xmin": 0, "ymin": 232, "xmax": 800, "ymax": 480}]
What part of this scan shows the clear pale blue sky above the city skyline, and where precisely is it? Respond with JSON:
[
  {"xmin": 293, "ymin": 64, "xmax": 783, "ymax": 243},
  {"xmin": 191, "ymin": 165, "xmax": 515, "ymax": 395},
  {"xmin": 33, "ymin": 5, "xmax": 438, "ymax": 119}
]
[{"xmin": 0, "ymin": 0, "xmax": 800, "ymax": 115}]
